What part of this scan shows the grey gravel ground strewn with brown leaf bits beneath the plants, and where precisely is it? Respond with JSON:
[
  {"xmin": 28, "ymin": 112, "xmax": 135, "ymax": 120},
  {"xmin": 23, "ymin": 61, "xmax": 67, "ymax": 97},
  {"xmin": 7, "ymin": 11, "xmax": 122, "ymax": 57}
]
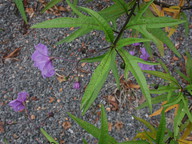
[{"xmin": 0, "ymin": 0, "xmax": 192, "ymax": 144}]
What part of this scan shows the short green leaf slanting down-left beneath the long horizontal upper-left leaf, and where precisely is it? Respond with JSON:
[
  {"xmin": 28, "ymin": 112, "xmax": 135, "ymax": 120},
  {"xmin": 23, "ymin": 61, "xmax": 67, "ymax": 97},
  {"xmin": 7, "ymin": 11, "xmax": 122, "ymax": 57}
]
[{"xmin": 56, "ymin": 27, "xmax": 91, "ymax": 45}]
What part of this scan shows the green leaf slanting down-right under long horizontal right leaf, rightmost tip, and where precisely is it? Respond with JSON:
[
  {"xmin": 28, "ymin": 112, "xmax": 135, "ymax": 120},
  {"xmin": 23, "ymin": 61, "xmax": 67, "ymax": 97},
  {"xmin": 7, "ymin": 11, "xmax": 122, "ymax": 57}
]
[{"xmin": 149, "ymin": 29, "xmax": 181, "ymax": 58}]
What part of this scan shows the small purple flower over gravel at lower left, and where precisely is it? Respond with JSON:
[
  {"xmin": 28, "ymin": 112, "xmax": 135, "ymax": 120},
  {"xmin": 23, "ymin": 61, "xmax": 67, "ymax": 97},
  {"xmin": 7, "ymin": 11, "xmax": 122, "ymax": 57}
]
[{"xmin": 9, "ymin": 92, "xmax": 29, "ymax": 112}]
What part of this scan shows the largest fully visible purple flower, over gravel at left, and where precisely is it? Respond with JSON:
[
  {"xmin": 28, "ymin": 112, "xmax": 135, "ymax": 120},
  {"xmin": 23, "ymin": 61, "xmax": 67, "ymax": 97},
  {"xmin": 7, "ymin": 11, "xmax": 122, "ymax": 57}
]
[{"xmin": 31, "ymin": 44, "xmax": 55, "ymax": 78}]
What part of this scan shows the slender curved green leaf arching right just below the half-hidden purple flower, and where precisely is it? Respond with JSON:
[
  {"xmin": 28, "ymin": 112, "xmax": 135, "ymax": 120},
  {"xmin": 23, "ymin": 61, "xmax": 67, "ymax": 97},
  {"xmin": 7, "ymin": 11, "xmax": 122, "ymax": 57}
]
[{"xmin": 143, "ymin": 70, "xmax": 180, "ymax": 88}]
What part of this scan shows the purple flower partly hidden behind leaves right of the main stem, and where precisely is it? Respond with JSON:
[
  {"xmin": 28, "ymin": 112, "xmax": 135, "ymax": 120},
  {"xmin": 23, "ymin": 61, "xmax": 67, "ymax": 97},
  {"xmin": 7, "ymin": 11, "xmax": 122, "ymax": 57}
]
[{"xmin": 138, "ymin": 48, "xmax": 155, "ymax": 70}]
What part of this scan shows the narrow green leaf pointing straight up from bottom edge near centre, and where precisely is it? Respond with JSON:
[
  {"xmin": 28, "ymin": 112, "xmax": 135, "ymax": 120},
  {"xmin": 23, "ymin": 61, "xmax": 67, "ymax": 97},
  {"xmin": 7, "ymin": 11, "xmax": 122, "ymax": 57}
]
[{"xmin": 98, "ymin": 105, "xmax": 109, "ymax": 144}]
